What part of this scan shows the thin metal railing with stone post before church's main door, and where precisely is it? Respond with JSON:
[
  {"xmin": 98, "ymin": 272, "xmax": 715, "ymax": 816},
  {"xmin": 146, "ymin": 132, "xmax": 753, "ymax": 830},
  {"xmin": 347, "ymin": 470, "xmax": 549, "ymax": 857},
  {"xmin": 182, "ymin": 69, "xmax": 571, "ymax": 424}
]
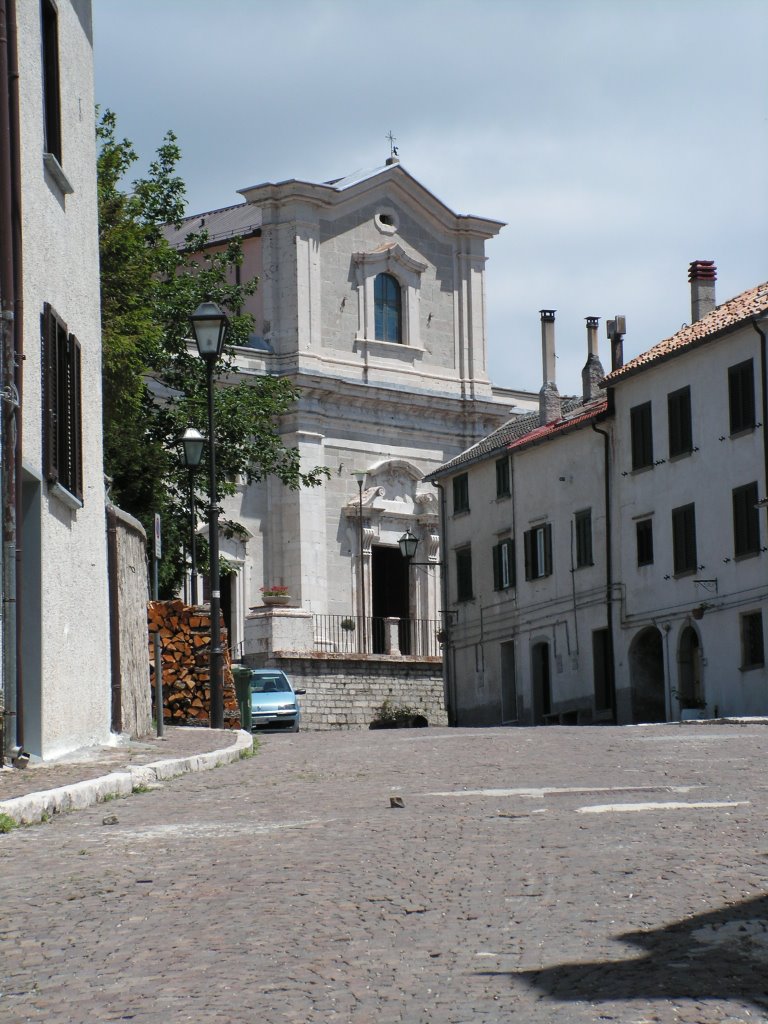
[{"xmin": 312, "ymin": 615, "xmax": 442, "ymax": 657}]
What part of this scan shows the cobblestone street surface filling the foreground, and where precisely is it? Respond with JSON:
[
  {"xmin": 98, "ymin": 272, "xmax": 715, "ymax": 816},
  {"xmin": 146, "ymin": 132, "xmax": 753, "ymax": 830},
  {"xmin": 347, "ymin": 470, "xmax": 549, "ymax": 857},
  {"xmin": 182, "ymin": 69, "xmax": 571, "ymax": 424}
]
[{"xmin": 0, "ymin": 725, "xmax": 768, "ymax": 1024}]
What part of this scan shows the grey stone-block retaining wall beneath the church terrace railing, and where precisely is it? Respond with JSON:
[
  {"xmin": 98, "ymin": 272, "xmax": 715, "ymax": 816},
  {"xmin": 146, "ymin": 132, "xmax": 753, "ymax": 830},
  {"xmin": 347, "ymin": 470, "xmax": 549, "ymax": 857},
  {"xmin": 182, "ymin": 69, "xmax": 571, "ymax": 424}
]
[{"xmin": 249, "ymin": 654, "xmax": 447, "ymax": 730}]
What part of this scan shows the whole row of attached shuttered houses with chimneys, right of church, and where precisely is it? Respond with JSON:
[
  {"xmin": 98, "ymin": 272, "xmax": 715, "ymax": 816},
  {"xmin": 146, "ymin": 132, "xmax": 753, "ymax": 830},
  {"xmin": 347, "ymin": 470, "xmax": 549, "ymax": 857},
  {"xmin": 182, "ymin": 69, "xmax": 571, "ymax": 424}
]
[{"xmin": 429, "ymin": 261, "xmax": 768, "ymax": 724}]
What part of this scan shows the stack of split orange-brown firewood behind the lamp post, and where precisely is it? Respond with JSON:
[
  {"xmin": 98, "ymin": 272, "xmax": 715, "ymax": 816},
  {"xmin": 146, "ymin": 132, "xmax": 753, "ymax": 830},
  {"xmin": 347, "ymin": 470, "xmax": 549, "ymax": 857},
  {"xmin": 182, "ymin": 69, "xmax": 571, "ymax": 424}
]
[{"xmin": 147, "ymin": 601, "xmax": 240, "ymax": 729}]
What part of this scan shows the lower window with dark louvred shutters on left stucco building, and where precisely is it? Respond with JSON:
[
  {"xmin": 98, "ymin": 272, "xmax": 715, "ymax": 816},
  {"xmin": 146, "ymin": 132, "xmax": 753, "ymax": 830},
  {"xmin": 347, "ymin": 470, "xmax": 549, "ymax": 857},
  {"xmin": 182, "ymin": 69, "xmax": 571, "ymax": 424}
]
[{"xmin": 41, "ymin": 302, "xmax": 83, "ymax": 503}]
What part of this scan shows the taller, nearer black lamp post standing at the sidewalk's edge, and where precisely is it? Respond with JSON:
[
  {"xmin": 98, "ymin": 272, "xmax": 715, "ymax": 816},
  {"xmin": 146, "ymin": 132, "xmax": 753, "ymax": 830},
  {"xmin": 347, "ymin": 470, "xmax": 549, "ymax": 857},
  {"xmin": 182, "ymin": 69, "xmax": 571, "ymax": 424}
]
[{"xmin": 191, "ymin": 302, "xmax": 228, "ymax": 729}]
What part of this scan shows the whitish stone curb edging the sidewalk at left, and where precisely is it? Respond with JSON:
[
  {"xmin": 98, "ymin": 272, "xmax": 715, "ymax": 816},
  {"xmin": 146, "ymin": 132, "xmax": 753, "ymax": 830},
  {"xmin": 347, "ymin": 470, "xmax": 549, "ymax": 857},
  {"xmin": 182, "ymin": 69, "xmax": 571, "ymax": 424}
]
[{"xmin": 0, "ymin": 730, "xmax": 253, "ymax": 825}]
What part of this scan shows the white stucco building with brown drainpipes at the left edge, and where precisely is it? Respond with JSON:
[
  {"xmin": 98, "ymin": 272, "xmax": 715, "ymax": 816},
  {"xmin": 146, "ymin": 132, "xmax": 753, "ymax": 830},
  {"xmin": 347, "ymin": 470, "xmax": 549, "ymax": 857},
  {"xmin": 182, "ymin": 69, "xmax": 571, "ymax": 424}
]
[{"xmin": 0, "ymin": 0, "xmax": 111, "ymax": 757}]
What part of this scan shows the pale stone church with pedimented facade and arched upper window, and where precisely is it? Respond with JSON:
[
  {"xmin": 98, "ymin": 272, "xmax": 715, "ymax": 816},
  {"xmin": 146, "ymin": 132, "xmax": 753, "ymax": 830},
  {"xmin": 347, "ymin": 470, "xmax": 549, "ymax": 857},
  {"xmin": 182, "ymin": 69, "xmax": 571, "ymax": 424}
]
[{"xmin": 169, "ymin": 157, "xmax": 534, "ymax": 656}]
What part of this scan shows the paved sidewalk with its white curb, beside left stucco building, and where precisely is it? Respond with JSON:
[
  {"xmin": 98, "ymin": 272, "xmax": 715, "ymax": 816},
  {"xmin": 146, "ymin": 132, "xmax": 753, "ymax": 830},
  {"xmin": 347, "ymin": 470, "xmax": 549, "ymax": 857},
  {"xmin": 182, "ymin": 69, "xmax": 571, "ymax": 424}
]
[{"xmin": 0, "ymin": 726, "xmax": 252, "ymax": 824}]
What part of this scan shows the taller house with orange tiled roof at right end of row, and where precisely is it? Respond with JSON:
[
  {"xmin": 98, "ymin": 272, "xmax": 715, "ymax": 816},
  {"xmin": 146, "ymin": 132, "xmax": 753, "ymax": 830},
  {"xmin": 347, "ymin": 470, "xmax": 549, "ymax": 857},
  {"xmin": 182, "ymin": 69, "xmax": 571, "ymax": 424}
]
[{"xmin": 605, "ymin": 261, "xmax": 768, "ymax": 721}]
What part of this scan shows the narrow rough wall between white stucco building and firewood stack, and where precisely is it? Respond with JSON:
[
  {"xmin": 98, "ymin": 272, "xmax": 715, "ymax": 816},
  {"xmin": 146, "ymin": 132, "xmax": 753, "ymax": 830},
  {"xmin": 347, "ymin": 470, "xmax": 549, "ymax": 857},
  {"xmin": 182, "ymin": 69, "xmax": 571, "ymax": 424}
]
[{"xmin": 106, "ymin": 505, "xmax": 152, "ymax": 736}]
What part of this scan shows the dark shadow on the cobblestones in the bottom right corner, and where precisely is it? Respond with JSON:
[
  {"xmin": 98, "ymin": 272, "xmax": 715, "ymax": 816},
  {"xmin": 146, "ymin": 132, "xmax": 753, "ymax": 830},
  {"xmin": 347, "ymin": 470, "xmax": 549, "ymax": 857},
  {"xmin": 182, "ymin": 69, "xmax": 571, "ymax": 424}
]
[{"xmin": 501, "ymin": 896, "xmax": 768, "ymax": 1010}]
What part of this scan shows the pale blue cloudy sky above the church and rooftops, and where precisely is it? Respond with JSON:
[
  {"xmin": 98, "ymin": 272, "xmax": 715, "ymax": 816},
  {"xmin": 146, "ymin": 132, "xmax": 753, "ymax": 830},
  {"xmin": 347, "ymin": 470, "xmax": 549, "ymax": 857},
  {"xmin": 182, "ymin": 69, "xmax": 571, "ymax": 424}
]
[{"xmin": 93, "ymin": 0, "xmax": 768, "ymax": 394}]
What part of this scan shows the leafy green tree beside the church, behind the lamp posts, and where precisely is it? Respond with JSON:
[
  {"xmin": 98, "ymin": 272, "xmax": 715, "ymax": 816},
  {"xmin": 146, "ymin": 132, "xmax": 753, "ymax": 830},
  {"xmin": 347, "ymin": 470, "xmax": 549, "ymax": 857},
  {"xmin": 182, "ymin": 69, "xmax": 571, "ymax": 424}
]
[{"xmin": 96, "ymin": 111, "xmax": 329, "ymax": 595}]
